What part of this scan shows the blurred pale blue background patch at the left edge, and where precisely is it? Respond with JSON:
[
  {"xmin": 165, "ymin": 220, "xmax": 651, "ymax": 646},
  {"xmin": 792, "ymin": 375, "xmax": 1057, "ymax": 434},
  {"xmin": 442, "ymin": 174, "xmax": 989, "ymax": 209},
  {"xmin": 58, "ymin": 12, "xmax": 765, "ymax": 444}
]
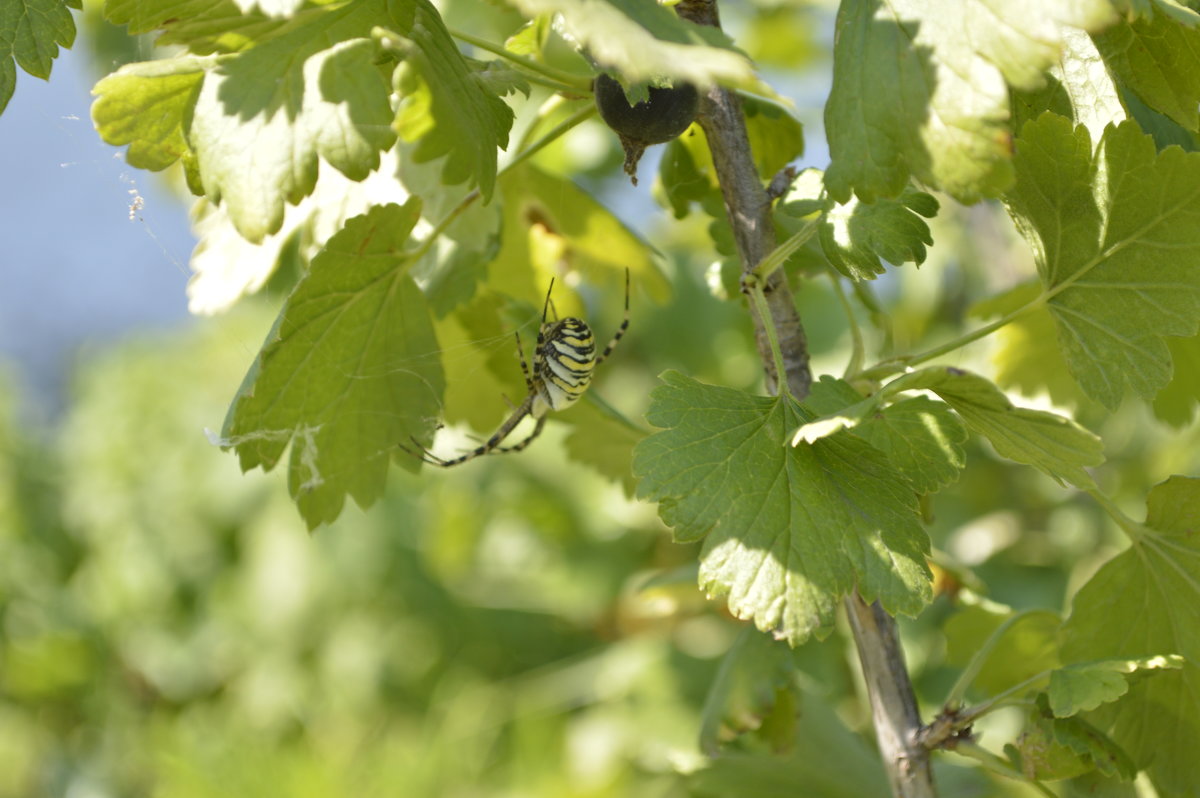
[{"xmin": 0, "ymin": 44, "xmax": 194, "ymax": 419}]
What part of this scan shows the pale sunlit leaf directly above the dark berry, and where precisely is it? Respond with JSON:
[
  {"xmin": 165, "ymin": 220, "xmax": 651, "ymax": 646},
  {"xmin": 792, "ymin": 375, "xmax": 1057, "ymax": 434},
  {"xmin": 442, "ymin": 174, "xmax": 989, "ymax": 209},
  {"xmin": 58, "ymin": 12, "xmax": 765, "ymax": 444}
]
[{"xmin": 514, "ymin": 0, "xmax": 753, "ymax": 91}]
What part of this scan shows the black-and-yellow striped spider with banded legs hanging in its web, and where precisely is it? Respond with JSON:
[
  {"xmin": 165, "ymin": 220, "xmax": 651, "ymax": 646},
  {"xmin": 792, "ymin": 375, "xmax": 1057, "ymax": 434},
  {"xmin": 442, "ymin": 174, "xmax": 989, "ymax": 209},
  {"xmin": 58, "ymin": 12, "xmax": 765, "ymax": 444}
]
[{"xmin": 401, "ymin": 269, "xmax": 629, "ymax": 468}]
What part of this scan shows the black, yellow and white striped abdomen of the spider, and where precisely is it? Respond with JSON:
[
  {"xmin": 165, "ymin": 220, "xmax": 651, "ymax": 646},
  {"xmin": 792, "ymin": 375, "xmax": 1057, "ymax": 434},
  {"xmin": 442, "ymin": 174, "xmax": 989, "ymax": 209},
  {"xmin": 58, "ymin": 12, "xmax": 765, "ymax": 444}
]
[{"xmin": 532, "ymin": 318, "xmax": 596, "ymax": 419}]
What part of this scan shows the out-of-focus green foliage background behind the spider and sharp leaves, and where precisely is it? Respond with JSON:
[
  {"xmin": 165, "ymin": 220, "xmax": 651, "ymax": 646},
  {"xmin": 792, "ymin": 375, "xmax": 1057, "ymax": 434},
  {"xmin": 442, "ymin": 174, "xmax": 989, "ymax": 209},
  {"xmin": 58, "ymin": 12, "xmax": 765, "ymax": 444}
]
[{"xmin": 0, "ymin": 0, "xmax": 1200, "ymax": 798}]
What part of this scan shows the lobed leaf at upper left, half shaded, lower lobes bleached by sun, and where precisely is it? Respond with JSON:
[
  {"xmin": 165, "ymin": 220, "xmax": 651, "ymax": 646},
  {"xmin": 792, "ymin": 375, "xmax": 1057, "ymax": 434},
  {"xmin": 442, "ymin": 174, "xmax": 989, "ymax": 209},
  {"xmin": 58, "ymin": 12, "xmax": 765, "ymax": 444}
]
[{"xmin": 187, "ymin": 31, "xmax": 395, "ymax": 242}]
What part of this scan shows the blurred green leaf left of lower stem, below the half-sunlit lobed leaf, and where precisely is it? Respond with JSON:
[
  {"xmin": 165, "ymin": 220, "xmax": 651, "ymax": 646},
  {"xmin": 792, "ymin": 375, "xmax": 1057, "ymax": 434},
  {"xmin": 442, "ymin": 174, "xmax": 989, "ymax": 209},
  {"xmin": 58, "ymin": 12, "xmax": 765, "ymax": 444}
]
[{"xmin": 700, "ymin": 626, "xmax": 796, "ymax": 756}]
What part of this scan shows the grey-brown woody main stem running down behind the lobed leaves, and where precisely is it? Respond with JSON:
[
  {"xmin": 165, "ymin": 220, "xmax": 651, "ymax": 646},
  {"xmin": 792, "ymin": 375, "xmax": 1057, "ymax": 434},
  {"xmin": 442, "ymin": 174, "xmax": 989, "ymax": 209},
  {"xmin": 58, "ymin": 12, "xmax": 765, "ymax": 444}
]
[{"xmin": 676, "ymin": 0, "xmax": 935, "ymax": 798}]
